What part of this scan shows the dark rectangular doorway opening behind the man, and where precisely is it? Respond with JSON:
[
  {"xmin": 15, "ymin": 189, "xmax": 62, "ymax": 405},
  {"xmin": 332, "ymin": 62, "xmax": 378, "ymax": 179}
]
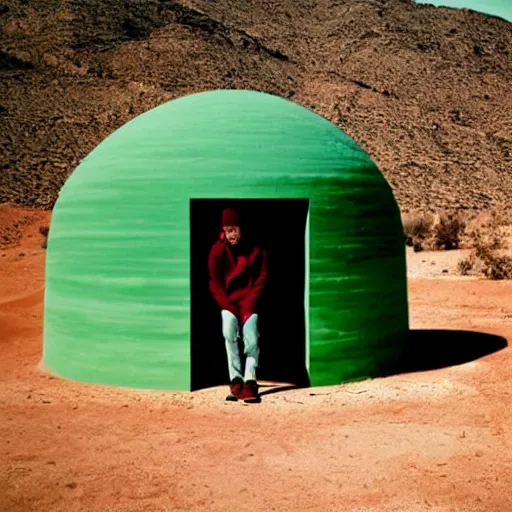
[{"xmin": 190, "ymin": 199, "xmax": 309, "ymax": 391}]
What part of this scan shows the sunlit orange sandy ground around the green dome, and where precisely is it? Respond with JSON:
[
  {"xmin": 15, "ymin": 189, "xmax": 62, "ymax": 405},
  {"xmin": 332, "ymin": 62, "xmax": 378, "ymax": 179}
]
[{"xmin": 0, "ymin": 208, "xmax": 512, "ymax": 512}]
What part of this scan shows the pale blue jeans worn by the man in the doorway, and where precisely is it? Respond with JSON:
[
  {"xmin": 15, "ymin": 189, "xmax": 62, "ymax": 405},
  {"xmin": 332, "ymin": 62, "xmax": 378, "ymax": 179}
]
[{"xmin": 221, "ymin": 309, "xmax": 260, "ymax": 381}]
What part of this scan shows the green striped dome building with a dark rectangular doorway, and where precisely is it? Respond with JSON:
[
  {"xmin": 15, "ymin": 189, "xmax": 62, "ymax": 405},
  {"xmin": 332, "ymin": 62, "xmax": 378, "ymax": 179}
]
[{"xmin": 43, "ymin": 90, "xmax": 409, "ymax": 391}]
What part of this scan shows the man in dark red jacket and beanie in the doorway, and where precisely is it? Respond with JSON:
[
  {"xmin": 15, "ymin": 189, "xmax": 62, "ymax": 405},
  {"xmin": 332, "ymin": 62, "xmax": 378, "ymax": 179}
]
[{"xmin": 208, "ymin": 208, "xmax": 268, "ymax": 402}]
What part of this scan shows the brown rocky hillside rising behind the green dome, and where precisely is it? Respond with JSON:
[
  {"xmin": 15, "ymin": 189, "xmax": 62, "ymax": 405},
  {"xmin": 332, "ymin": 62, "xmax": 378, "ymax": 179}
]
[{"xmin": 0, "ymin": 0, "xmax": 512, "ymax": 211}]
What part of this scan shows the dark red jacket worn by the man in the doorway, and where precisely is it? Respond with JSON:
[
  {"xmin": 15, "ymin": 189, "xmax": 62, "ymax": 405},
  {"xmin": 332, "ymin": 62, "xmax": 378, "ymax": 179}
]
[{"xmin": 208, "ymin": 235, "xmax": 268, "ymax": 322}]
